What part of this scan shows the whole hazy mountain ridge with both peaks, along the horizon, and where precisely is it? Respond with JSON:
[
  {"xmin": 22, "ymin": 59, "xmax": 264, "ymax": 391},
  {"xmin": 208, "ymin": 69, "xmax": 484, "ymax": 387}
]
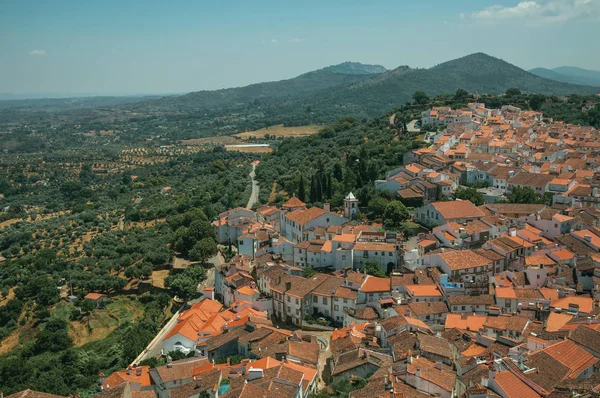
[{"xmin": 144, "ymin": 53, "xmax": 600, "ymax": 116}]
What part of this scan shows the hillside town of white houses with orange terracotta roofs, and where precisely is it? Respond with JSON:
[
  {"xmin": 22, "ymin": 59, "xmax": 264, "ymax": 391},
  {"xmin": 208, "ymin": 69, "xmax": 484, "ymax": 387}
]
[{"xmin": 36, "ymin": 103, "xmax": 600, "ymax": 398}]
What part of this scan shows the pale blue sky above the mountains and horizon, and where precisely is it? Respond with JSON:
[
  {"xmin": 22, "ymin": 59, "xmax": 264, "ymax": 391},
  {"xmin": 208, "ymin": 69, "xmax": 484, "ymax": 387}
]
[{"xmin": 0, "ymin": 0, "xmax": 600, "ymax": 96}]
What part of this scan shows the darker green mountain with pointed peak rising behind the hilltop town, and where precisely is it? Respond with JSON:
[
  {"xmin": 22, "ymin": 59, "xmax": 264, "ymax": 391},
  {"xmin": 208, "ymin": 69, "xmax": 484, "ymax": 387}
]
[{"xmin": 292, "ymin": 53, "xmax": 600, "ymax": 116}]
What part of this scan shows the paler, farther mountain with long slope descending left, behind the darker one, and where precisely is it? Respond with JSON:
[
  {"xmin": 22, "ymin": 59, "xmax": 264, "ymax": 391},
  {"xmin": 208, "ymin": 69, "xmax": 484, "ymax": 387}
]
[{"xmin": 153, "ymin": 62, "xmax": 386, "ymax": 109}]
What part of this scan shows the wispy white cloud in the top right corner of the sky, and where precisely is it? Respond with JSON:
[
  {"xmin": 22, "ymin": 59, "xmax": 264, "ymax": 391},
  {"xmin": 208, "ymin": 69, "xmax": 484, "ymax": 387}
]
[{"xmin": 468, "ymin": 0, "xmax": 600, "ymax": 23}]
